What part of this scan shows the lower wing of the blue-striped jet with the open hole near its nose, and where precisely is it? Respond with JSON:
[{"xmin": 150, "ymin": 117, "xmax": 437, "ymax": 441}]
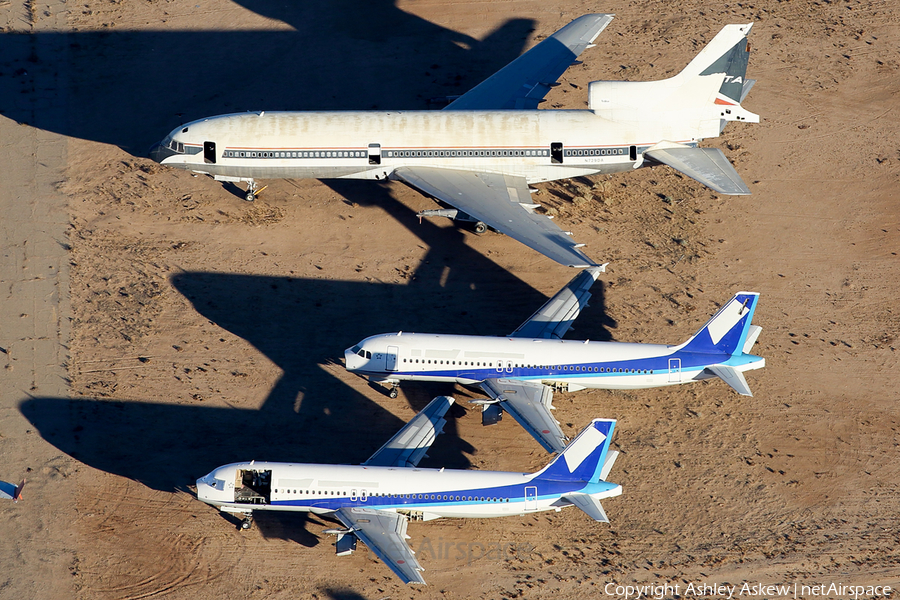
[{"xmin": 335, "ymin": 507, "xmax": 425, "ymax": 583}]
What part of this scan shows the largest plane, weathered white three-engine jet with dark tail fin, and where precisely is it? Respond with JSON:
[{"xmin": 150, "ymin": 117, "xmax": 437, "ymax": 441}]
[{"xmin": 150, "ymin": 14, "xmax": 759, "ymax": 267}]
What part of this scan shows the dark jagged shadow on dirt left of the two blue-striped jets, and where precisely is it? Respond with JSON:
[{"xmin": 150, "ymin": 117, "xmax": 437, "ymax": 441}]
[{"xmin": 21, "ymin": 197, "xmax": 615, "ymax": 491}]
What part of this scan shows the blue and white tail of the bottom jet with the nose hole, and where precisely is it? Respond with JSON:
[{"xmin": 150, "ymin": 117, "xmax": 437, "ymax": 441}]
[{"xmin": 534, "ymin": 419, "xmax": 622, "ymax": 523}]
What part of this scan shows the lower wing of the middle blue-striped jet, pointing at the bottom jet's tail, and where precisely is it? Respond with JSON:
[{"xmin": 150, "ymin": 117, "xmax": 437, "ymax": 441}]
[{"xmin": 481, "ymin": 379, "xmax": 568, "ymax": 452}]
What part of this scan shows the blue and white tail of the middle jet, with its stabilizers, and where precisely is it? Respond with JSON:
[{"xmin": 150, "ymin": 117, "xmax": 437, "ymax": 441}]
[{"xmin": 675, "ymin": 292, "xmax": 766, "ymax": 396}]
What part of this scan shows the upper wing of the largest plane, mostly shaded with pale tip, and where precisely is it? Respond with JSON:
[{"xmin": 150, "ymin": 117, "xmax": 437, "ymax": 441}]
[{"xmin": 444, "ymin": 14, "xmax": 613, "ymax": 110}]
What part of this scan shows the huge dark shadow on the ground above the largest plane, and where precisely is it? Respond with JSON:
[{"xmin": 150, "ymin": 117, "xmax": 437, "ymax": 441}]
[{"xmin": 0, "ymin": 0, "xmax": 533, "ymax": 156}]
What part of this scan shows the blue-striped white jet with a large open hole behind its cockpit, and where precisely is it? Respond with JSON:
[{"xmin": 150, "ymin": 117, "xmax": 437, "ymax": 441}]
[{"xmin": 197, "ymin": 396, "xmax": 622, "ymax": 583}]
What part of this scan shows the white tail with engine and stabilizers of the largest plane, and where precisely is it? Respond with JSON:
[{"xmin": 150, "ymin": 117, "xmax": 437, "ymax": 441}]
[{"xmin": 588, "ymin": 23, "xmax": 759, "ymax": 195}]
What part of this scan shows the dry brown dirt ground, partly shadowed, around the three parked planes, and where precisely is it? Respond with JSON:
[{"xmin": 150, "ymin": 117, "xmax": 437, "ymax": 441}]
[{"xmin": 0, "ymin": 0, "xmax": 900, "ymax": 600}]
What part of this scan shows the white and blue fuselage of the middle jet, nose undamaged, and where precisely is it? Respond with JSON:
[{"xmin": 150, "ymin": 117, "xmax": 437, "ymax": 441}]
[{"xmin": 344, "ymin": 333, "xmax": 765, "ymax": 391}]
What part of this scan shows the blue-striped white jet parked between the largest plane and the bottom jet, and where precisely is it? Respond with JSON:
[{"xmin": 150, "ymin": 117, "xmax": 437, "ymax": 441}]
[{"xmin": 344, "ymin": 267, "xmax": 766, "ymax": 452}]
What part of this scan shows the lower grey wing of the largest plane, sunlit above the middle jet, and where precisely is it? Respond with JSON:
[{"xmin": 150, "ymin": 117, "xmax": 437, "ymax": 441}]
[{"xmin": 394, "ymin": 167, "xmax": 597, "ymax": 268}]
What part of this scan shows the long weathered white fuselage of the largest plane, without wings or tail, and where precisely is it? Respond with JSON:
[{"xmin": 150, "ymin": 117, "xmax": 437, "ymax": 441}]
[{"xmin": 153, "ymin": 110, "xmax": 708, "ymax": 183}]
